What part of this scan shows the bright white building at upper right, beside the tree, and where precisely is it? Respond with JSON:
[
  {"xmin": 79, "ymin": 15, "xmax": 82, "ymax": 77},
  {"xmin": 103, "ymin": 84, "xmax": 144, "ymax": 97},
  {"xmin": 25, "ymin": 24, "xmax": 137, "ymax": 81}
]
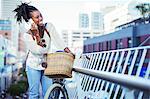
[{"xmin": 104, "ymin": 0, "xmax": 140, "ymax": 33}]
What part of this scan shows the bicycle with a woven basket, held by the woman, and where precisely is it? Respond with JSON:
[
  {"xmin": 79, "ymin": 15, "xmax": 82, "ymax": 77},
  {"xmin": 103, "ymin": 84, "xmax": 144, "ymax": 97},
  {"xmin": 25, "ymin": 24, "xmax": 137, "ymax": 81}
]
[{"xmin": 44, "ymin": 52, "xmax": 75, "ymax": 99}]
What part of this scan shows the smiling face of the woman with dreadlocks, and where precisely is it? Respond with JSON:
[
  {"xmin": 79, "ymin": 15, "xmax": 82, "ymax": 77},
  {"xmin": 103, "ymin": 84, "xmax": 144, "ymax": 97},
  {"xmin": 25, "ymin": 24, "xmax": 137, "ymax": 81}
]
[{"xmin": 31, "ymin": 10, "xmax": 43, "ymax": 25}]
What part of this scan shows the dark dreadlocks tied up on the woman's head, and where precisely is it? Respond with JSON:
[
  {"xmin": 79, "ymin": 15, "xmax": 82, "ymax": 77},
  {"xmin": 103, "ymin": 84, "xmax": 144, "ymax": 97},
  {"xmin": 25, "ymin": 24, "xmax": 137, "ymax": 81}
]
[{"xmin": 13, "ymin": 3, "xmax": 38, "ymax": 23}]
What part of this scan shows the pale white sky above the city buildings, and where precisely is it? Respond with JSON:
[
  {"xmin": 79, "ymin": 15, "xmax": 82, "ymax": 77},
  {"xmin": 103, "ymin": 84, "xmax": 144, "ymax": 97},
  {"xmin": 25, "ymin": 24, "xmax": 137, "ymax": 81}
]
[{"xmin": 27, "ymin": 0, "xmax": 150, "ymax": 33}]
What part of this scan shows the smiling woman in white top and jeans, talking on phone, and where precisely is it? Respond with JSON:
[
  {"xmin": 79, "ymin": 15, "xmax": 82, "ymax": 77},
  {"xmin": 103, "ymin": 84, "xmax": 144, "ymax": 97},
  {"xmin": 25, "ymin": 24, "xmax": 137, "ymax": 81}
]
[{"xmin": 14, "ymin": 3, "xmax": 70, "ymax": 99}]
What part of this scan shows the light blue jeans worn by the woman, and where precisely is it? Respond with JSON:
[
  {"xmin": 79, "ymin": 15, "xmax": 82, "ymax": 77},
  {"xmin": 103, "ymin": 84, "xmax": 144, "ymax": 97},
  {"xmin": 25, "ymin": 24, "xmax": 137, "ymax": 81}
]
[{"xmin": 26, "ymin": 66, "xmax": 52, "ymax": 99}]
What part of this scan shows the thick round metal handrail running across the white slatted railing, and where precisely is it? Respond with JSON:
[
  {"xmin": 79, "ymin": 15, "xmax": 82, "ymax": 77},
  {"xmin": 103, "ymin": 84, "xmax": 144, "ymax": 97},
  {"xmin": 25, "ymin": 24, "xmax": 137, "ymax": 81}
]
[{"xmin": 73, "ymin": 67, "xmax": 150, "ymax": 91}]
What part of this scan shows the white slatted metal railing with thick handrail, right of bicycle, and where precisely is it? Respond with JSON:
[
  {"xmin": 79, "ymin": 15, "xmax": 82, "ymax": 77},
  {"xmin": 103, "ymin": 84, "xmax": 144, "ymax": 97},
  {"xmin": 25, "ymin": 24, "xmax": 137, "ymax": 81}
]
[{"xmin": 67, "ymin": 46, "xmax": 150, "ymax": 99}]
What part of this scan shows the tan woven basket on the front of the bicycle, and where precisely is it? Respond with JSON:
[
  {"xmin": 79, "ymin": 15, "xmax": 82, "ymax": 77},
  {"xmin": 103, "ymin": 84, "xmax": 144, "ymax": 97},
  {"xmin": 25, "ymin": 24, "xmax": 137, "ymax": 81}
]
[{"xmin": 44, "ymin": 52, "xmax": 74, "ymax": 78}]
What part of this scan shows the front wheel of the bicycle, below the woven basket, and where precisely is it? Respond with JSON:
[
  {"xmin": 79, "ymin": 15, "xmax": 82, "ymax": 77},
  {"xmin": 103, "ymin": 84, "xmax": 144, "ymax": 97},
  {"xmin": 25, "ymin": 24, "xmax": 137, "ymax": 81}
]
[{"xmin": 44, "ymin": 83, "xmax": 69, "ymax": 99}]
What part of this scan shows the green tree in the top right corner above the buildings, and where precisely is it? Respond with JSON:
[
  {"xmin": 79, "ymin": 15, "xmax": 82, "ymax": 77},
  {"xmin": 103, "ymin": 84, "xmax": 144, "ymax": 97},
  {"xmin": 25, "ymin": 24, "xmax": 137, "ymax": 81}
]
[{"xmin": 135, "ymin": 3, "xmax": 150, "ymax": 18}]
